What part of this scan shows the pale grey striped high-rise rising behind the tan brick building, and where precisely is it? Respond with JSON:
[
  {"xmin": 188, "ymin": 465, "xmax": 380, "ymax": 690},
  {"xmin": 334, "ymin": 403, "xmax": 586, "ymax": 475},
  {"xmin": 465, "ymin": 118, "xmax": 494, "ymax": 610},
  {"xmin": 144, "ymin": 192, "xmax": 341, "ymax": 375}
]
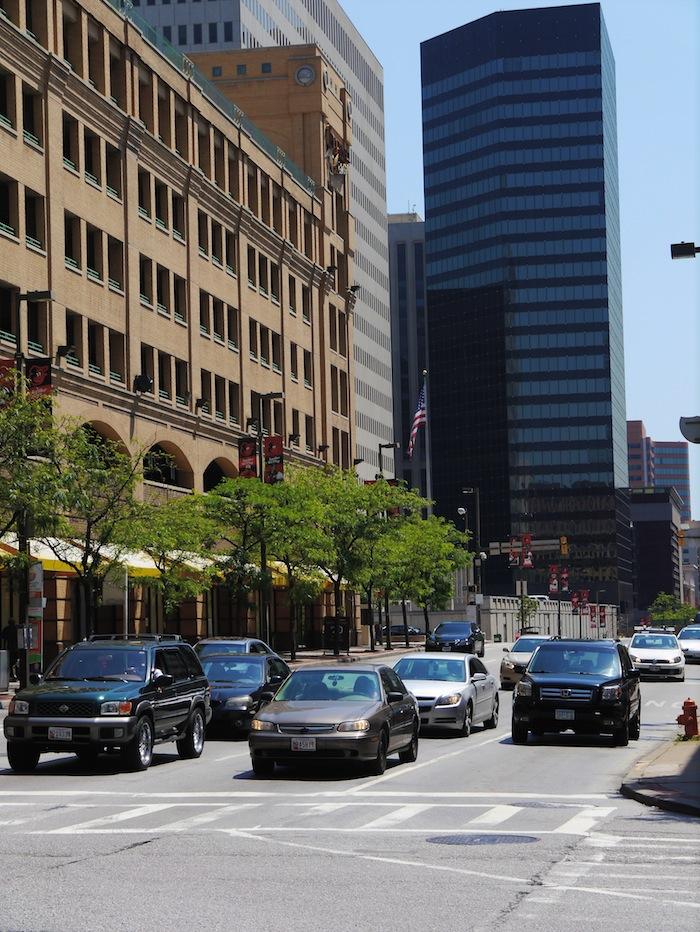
[{"xmin": 134, "ymin": 0, "xmax": 398, "ymax": 479}]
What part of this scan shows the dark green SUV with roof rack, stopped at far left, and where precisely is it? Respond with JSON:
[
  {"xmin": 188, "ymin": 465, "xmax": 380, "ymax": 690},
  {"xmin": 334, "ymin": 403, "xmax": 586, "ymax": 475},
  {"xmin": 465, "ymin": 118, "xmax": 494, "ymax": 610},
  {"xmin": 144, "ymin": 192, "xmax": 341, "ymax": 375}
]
[{"xmin": 4, "ymin": 637, "xmax": 211, "ymax": 773}]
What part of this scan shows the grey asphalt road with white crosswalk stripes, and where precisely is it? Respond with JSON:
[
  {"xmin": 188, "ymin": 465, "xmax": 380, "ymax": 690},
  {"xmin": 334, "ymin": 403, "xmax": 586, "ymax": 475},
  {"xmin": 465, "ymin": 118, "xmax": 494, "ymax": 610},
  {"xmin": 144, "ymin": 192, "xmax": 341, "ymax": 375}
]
[{"xmin": 0, "ymin": 646, "xmax": 700, "ymax": 932}]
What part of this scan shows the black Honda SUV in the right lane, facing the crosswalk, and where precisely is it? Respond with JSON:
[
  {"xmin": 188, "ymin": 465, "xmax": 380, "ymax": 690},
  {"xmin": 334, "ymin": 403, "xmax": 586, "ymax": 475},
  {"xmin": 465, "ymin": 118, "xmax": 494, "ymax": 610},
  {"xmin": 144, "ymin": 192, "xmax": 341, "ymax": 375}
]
[{"xmin": 512, "ymin": 639, "xmax": 640, "ymax": 746}]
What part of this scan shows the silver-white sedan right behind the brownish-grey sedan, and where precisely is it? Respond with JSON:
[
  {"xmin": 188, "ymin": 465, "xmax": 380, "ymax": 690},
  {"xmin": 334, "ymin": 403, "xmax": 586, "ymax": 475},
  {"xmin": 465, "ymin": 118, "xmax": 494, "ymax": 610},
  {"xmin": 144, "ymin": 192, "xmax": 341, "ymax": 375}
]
[{"xmin": 394, "ymin": 652, "xmax": 498, "ymax": 737}]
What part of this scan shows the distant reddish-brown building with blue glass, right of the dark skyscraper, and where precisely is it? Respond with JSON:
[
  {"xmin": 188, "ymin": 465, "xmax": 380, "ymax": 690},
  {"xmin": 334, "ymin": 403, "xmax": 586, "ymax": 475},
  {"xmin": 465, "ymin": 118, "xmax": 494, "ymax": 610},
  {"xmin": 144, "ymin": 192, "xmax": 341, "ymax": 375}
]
[{"xmin": 627, "ymin": 421, "xmax": 691, "ymax": 523}]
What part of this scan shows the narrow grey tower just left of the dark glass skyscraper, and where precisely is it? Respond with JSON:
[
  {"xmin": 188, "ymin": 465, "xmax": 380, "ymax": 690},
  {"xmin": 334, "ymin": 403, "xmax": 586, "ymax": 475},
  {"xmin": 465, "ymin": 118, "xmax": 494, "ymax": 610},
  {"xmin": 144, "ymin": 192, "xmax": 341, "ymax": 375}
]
[{"xmin": 389, "ymin": 213, "xmax": 429, "ymax": 495}]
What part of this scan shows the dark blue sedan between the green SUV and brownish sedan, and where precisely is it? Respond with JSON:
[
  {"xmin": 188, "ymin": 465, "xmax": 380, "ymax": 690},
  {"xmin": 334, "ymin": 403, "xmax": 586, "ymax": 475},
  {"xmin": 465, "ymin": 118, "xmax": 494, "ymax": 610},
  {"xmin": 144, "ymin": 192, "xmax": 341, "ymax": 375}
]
[{"xmin": 202, "ymin": 654, "xmax": 291, "ymax": 734}]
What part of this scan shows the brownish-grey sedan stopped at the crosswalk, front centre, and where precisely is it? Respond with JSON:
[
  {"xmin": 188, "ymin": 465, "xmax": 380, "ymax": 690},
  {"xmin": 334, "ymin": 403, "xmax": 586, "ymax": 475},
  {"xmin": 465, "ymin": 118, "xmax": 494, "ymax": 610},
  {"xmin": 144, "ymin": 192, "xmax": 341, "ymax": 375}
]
[{"xmin": 248, "ymin": 664, "xmax": 419, "ymax": 776}]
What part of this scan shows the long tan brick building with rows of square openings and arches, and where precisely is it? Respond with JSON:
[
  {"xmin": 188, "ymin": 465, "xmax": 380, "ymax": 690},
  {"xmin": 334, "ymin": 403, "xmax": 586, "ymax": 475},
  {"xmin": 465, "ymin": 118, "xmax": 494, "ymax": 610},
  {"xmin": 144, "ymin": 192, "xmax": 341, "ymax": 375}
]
[{"xmin": 0, "ymin": 0, "xmax": 354, "ymax": 652}]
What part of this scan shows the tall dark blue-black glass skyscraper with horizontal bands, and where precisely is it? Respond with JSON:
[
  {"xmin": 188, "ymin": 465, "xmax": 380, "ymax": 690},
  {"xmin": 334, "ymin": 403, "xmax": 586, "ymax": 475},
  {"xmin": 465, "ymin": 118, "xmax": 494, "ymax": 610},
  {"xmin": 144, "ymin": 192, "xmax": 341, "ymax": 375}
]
[{"xmin": 421, "ymin": 4, "xmax": 631, "ymax": 602}]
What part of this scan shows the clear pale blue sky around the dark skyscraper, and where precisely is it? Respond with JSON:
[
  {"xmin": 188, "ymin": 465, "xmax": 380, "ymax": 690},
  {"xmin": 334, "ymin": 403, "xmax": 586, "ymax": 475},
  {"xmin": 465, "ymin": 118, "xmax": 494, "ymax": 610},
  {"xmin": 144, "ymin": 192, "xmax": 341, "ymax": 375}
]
[{"xmin": 340, "ymin": 0, "xmax": 700, "ymax": 519}]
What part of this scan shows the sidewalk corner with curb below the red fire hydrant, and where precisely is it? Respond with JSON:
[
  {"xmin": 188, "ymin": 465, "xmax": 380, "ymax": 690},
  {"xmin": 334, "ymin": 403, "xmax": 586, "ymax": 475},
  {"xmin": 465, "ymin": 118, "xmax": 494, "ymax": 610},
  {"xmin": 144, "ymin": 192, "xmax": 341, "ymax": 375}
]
[{"xmin": 620, "ymin": 739, "xmax": 700, "ymax": 817}]
